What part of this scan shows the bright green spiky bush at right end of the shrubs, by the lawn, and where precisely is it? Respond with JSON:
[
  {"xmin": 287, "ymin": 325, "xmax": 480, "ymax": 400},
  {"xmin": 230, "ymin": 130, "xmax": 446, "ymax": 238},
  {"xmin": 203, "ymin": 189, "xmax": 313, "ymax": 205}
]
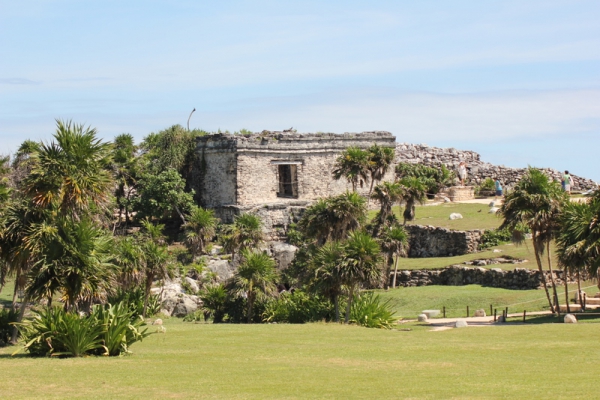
[{"xmin": 350, "ymin": 292, "xmax": 396, "ymax": 329}]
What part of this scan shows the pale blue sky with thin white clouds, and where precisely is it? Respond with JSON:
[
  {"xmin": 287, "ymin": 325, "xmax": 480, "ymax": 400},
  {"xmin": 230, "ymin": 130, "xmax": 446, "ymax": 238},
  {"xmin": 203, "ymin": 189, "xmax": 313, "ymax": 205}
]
[{"xmin": 0, "ymin": 0, "xmax": 600, "ymax": 181}]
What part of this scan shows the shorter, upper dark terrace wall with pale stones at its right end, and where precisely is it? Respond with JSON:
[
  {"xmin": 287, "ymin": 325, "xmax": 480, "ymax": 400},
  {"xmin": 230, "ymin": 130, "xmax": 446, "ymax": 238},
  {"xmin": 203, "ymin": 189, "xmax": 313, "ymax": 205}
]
[{"xmin": 405, "ymin": 225, "xmax": 484, "ymax": 257}]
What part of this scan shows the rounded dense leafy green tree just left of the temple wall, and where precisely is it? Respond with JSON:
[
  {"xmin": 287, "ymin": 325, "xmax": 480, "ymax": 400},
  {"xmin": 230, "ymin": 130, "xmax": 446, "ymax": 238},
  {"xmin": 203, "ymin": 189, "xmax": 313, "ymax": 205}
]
[{"xmin": 133, "ymin": 169, "xmax": 194, "ymax": 224}]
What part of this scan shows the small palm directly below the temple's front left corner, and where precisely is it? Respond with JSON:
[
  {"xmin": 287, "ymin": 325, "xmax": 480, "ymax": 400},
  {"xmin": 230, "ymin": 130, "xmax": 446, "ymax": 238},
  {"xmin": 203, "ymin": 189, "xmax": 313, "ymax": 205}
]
[{"xmin": 223, "ymin": 213, "xmax": 265, "ymax": 260}]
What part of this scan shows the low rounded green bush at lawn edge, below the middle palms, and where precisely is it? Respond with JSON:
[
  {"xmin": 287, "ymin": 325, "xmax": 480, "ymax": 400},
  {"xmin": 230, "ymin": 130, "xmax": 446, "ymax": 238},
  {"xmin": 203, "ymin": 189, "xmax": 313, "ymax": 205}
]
[{"xmin": 262, "ymin": 290, "xmax": 333, "ymax": 324}]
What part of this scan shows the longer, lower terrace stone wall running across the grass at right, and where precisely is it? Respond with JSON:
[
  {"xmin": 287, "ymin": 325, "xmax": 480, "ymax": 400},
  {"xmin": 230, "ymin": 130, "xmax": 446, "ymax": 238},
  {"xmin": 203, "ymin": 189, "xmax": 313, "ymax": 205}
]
[{"xmin": 390, "ymin": 265, "xmax": 575, "ymax": 290}]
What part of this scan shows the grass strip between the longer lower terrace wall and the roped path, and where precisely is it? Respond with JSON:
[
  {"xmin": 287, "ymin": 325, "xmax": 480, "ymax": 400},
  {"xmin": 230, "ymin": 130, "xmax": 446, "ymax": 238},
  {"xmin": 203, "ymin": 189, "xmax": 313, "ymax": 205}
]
[{"xmin": 377, "ymin": 282, "xmax": 598, "ymax": 318}]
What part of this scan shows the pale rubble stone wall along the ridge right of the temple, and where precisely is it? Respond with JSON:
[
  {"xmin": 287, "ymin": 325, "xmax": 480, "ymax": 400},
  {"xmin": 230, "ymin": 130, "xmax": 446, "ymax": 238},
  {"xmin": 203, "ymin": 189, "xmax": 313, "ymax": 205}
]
[{"xmin": 395, "ymin": 143, "xmax": 597, "ymax": 190}]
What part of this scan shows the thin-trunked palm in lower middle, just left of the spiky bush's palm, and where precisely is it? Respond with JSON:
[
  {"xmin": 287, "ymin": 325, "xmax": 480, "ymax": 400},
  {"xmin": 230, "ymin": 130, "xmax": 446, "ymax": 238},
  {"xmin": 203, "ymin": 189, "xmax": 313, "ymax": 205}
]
[{"xmin": 310, "ymin": 241, "xmax": 345, "ymax": 322}]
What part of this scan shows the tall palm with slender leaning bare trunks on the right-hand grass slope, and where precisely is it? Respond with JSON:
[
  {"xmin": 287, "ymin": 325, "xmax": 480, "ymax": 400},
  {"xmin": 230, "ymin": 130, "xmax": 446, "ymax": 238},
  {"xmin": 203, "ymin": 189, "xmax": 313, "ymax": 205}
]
[{"xmin": 499, "ymin": 167, "xmax": 567, "ymax": 313}]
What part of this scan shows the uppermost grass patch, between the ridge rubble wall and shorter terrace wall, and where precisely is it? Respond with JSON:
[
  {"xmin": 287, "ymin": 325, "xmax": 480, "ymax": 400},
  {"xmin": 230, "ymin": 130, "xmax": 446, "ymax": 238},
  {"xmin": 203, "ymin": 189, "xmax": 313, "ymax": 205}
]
[{"xmin": 369, "ymin": 203, "xmax": 502, "ymax": 230}]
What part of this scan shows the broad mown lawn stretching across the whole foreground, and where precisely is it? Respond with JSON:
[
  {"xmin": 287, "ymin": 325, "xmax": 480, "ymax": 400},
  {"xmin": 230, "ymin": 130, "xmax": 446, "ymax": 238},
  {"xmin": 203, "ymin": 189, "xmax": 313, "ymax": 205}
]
[{"xmin": 0, "ymin": 319, "xmax": 600, "ymax": 399}]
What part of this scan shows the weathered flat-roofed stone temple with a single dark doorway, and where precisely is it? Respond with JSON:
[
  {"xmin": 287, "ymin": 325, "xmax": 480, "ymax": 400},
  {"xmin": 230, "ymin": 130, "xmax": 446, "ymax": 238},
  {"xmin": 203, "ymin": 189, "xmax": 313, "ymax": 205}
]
[{"xmin": 194, "ymin": 131, "xmax": 396, "ymax": 239}]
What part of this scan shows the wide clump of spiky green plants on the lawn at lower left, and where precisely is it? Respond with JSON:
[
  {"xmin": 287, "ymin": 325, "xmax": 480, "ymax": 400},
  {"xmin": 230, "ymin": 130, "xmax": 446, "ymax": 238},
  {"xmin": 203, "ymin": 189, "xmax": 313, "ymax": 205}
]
[{"xmin": 16, "ymin": 303, "xmax": 149, "ymax": 357}]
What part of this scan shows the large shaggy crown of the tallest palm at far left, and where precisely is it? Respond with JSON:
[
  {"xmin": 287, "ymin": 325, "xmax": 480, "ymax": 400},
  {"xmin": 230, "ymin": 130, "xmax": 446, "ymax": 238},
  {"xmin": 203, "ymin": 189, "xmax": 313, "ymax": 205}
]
[{"xmin": 25, "ymin": 120, "xmax": 112, "ymax": 219}]
